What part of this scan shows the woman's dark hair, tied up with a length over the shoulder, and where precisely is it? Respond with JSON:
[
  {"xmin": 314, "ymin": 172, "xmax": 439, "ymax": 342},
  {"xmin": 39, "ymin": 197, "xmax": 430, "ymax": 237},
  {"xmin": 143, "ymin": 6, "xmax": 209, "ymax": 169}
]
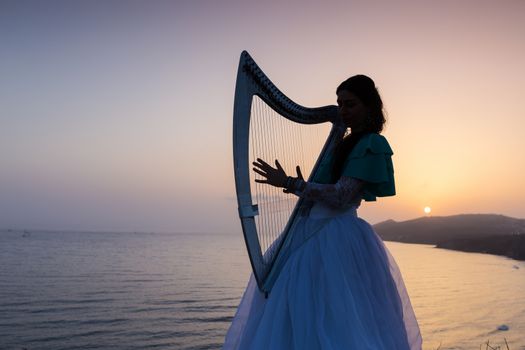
[{"xmin": 332, "ymin": 74, "xmax": 386, "ymax": 183}]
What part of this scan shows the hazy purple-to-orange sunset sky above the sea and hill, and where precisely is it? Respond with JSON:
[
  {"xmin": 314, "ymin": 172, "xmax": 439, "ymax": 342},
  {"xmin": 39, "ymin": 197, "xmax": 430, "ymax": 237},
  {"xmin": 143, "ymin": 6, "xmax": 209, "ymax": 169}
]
[{"xmin": 0, "ymin": 0, "xmax": 525, "ymax": 232}]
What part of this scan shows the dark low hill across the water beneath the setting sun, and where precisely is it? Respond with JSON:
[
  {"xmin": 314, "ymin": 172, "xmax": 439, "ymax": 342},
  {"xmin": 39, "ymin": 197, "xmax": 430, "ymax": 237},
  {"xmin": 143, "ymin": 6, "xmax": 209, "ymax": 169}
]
[{"xmin": 374, "ymin": 214, "xmax": 525, "ymax": 260}]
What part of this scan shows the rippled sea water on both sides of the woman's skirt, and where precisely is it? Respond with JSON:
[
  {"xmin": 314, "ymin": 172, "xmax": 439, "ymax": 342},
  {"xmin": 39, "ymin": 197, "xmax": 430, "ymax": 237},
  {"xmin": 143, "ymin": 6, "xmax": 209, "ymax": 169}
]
[{"xmin": 0, "ymin": 231, "xmax": 525, "ymax": 350}]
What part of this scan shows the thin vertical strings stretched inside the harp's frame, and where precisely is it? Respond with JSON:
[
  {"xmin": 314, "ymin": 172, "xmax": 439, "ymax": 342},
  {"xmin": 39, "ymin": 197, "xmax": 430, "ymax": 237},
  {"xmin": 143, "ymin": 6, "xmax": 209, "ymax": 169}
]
[{"xmin": 249, "ymin": 96, "xmax": 330, "ymax": 261}]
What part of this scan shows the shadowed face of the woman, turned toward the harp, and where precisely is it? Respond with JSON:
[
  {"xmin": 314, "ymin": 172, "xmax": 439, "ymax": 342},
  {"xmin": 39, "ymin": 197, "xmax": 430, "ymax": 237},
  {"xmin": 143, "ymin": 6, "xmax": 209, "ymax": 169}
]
[{"xmin": 337, "ymin": 90, "xmax": 370, "ymax": 132}]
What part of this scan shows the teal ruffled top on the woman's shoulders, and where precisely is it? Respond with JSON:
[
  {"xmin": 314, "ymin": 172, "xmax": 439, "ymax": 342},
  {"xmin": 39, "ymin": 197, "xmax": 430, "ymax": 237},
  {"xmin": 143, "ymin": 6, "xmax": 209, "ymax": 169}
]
[{"xmin": 314, "ymin": 134, "xmax": 396, "ymax": 201}]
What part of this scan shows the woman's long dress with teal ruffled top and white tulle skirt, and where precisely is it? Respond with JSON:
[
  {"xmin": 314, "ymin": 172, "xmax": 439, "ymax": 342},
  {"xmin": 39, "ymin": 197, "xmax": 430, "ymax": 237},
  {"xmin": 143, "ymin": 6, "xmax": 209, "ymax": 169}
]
[{"xmin": 223, "ymin": 134, "xmax": 422, "ymax": 350}]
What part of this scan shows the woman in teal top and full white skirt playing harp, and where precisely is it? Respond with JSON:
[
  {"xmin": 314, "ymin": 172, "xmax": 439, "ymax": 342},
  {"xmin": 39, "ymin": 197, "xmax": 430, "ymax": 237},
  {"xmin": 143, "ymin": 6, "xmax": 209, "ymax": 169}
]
[{"xmin": 224, "ymin": 75, "xmax": 421, "ymax": 350}]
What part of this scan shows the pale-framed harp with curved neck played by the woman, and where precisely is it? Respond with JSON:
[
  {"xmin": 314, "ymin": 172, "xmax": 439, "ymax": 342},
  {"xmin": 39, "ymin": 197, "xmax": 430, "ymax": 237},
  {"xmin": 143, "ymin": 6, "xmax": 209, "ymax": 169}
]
[{"xmin": 233, "ymin": 51, "xmax": 345, "ymax": 294}]
